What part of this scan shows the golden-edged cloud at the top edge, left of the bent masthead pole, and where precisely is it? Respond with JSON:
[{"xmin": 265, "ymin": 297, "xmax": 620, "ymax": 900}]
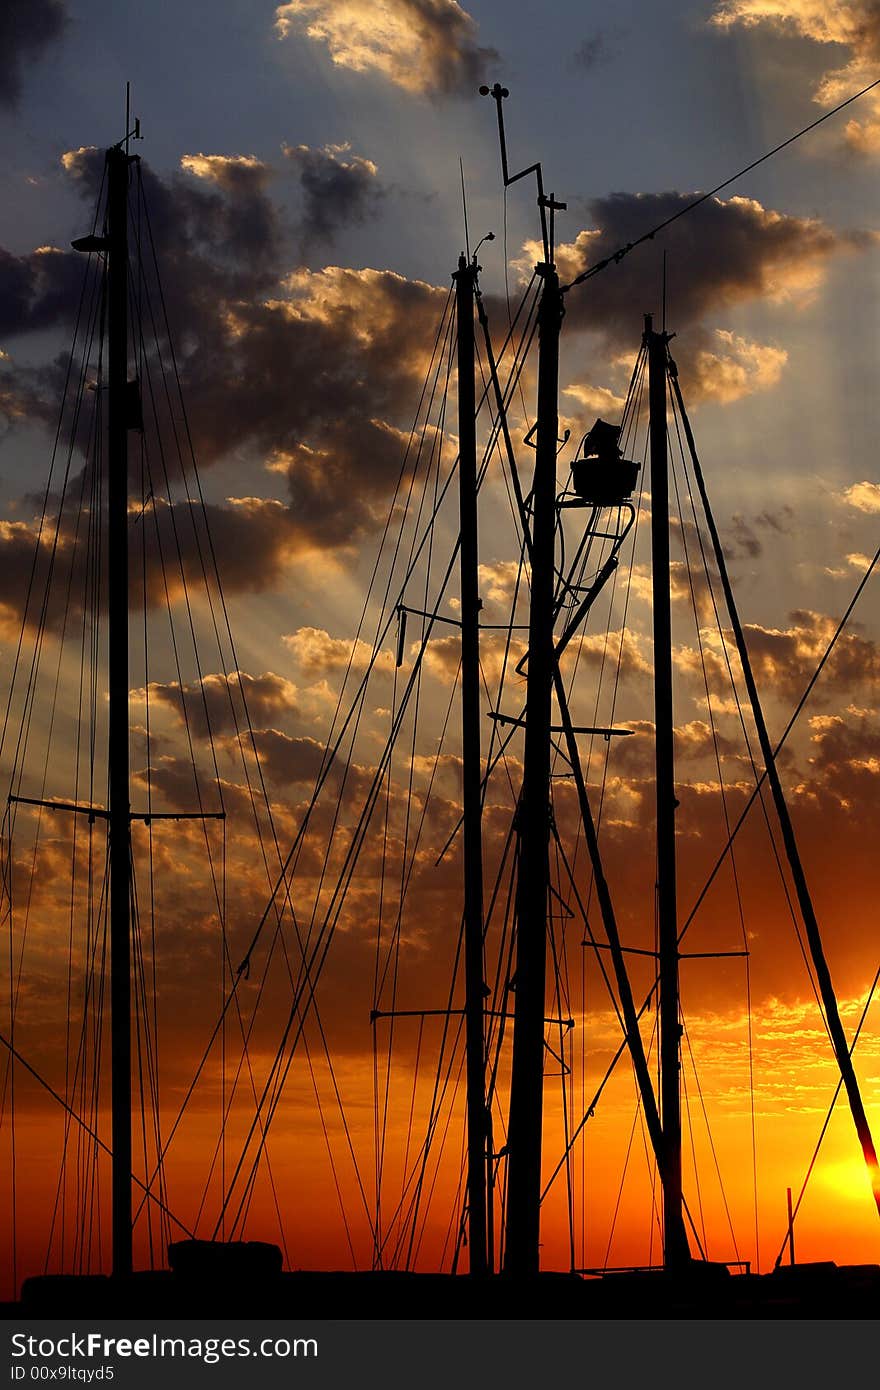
[{"xmin": 275, "ymin": 0, "xmax": 498, "ymax": 96}]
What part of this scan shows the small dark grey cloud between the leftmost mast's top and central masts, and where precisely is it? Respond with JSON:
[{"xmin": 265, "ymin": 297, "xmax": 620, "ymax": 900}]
[{"xmin": 284, "ymin": 145, "xmax": 384, "ymax": 249}]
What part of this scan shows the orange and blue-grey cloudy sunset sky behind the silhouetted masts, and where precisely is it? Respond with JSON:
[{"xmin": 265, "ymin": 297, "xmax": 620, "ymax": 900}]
[{"xmin": 0, "ymin": 0, "xmax": 880, "ymax": 1295}]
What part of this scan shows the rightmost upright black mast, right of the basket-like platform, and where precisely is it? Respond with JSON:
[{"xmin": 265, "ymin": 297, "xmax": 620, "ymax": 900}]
[{"xmin": 645, "ymin": 314, "xmax": 688, "ymax": 1269}]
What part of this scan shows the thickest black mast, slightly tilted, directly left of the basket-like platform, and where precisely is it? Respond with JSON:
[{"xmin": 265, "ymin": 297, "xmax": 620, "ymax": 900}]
[{"xmin": 505, "ymin": 263, "xmax": 563, "ymax": 1275}]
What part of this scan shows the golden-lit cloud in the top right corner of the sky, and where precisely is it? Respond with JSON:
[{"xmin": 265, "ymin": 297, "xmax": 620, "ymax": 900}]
[{"xmin": 712, "ymin": 0, "xmax": 880, "ymax": 154}]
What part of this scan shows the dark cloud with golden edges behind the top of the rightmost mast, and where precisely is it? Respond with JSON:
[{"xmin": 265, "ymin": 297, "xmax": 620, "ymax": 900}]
[{"xmin": 550, "ymin": 192, "xmax": 870, "ymax": 407}]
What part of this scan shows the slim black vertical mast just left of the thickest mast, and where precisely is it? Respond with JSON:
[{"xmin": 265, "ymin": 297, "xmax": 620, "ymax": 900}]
[{"xmin": 453, "ymin": 256, "xmax": 488, "ymax": 1275}]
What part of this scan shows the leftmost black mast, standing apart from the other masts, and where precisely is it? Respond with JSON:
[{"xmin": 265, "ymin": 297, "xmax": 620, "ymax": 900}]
[{"xmin": 107, "ymin": 146, "xmax": 132, "ymax": 1276}]
